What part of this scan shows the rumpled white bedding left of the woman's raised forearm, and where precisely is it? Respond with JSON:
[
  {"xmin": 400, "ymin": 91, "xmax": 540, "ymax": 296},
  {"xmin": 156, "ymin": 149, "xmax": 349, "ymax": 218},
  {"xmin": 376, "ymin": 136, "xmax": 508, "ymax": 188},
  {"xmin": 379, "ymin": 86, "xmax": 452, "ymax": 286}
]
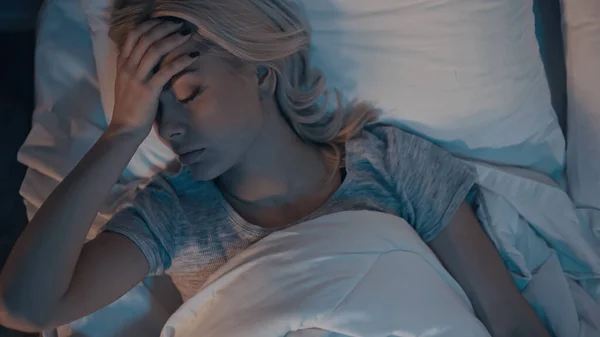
[{"xmin": 18, "ymin": 1, "xmax": 115, "ymax": 236}]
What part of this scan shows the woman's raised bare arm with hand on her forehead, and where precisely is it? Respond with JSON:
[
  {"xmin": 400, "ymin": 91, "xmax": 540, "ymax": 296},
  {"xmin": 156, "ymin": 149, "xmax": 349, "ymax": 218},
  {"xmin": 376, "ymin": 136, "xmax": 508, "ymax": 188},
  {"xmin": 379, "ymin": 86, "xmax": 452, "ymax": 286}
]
[{"xmin": 0, "ymin": 21, "xmax": 194, "ymax": 331}]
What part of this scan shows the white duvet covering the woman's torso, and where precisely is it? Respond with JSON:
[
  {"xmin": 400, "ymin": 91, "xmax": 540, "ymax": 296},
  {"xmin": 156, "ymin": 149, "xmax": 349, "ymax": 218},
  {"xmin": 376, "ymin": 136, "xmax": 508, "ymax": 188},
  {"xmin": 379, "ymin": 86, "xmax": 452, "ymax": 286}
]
[{"xmin": 163, "ymin": 211, "xmax": 488, "ymax": 337}]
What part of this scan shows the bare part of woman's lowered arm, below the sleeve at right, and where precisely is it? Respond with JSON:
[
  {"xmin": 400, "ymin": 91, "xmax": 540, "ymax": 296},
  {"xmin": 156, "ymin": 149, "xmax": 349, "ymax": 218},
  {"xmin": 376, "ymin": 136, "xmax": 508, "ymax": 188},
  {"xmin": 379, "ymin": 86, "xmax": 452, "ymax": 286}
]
[{"xmin": 430, "ymin": 202, "xmax": 550, "ymax": 337}]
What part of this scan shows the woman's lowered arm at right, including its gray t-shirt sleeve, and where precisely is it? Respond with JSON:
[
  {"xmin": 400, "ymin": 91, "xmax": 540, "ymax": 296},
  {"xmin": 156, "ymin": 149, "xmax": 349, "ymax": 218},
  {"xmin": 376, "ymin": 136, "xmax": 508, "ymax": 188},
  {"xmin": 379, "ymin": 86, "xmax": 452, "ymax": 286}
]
[{"xmin": 371, "ymin": 126, "xmax": 550, "ymax": 337}]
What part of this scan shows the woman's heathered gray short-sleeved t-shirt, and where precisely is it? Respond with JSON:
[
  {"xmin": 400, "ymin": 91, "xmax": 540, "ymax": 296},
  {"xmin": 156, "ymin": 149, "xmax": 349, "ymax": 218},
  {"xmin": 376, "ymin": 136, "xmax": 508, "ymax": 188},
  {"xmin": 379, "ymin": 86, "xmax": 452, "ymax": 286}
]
[{"xmin": 106, "ymin": 125, "xmax": 475, "ymax": 300}]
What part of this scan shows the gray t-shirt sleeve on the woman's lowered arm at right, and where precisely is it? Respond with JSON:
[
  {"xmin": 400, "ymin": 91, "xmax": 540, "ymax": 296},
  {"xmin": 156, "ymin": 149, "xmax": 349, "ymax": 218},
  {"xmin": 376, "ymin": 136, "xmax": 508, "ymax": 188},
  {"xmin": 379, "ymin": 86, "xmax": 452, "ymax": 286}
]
[{"xmin": 376, "ymin": 127, "xmax": 476, "ymax": 242}]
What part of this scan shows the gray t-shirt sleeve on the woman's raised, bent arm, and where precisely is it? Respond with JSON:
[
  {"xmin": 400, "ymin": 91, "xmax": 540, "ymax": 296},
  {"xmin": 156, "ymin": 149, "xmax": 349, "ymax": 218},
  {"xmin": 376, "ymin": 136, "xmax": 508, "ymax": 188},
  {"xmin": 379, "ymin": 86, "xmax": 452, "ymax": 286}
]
[{"xmin": 104, "ymin": 177, "xmax": 177, "ymax": 276}]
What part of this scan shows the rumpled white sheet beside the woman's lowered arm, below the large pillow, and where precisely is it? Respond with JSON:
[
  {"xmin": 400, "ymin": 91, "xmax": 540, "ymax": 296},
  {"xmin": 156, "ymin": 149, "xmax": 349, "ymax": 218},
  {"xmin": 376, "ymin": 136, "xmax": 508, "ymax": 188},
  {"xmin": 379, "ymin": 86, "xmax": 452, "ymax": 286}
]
[{"xmin": 475, "ymin": 163, "xmax": 600, "ymax": 337}]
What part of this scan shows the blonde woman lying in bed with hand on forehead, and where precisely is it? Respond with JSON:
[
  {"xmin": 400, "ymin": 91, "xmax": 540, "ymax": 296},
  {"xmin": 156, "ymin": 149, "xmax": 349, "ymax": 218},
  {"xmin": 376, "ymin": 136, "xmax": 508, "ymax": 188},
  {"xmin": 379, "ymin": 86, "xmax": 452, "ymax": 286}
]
[{"xmin": 0, "ymin": 0, "xmax": 548, "ymax": 336}]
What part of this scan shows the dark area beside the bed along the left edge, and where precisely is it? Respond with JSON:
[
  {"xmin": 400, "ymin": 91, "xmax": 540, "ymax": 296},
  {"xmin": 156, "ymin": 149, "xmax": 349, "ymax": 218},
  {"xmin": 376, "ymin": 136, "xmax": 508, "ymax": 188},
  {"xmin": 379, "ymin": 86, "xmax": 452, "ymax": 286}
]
[{"xmin": 0, "ymin": 0, "xmax": 41, "ymax": 337}]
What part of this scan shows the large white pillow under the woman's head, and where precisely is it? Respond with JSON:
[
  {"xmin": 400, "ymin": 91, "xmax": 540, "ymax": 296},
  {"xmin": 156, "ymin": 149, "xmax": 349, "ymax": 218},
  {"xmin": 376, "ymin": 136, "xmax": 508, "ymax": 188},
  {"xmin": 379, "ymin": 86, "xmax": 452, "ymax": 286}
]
[{"xmin": 81, "ymin": 0, "xmax": 565, "ymax": 181}]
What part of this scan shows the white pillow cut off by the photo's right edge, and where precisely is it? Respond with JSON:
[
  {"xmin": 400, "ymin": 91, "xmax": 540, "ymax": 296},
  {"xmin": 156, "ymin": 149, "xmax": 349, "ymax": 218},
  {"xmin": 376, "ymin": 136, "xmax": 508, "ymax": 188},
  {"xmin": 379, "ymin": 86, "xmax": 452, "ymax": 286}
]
[{"xmin": 561, "ymin": 0, "xmax": 600, "ymax": 233}]
